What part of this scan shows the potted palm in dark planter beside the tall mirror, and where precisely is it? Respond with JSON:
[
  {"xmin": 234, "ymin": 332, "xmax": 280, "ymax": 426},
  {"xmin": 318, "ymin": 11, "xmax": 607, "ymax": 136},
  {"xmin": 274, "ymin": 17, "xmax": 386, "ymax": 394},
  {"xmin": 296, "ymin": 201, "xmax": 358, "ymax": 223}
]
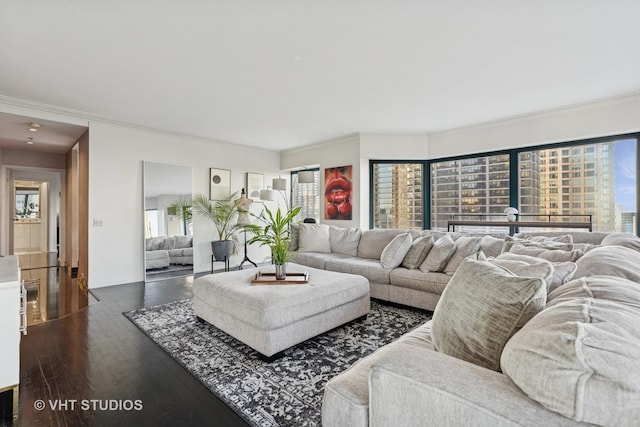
[{"xmin": 192, "ymin": 191, "xmax": 258, "ymax": 261}]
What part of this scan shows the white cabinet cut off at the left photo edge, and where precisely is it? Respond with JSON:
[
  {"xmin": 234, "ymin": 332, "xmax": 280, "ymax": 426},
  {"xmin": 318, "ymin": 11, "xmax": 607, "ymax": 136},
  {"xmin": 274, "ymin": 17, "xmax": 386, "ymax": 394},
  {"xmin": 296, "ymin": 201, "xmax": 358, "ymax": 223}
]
[{"xmin": 0, "ymin": 256, "xmax": 26, "ymax": 422}]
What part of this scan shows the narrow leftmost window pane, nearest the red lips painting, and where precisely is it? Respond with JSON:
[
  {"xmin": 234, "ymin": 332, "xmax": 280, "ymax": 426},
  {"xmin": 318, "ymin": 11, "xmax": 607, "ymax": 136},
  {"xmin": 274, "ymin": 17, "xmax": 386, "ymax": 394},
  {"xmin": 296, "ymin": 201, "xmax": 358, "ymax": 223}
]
[{"xmin": 371, "ymin": 162, "xmax": 424, "ymax": 230}]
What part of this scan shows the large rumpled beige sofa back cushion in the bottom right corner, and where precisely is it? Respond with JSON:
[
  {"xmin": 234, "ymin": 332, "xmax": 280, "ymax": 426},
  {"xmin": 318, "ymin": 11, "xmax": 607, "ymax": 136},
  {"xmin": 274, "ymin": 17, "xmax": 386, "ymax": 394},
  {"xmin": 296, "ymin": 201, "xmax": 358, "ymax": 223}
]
[{"xmin": 501, "ymin": 276, "xmax": 640, "ymax": 426}]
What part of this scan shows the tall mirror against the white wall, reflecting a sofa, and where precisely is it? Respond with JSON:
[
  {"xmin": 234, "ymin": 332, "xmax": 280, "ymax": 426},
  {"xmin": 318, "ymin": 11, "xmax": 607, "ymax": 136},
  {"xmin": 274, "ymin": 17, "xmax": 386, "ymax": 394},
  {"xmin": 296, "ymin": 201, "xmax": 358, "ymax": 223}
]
[{"xmin": 143, "ymin": 162, "xmax": 193, "ymax": 282}]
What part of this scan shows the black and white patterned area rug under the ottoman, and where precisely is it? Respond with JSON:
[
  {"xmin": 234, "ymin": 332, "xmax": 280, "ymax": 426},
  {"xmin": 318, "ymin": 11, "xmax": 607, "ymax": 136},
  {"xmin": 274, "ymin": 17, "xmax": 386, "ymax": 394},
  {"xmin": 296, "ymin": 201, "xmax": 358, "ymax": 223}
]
[{"xmin": 124, "ymin": 299, "xmax": 430, "ymax": 426}]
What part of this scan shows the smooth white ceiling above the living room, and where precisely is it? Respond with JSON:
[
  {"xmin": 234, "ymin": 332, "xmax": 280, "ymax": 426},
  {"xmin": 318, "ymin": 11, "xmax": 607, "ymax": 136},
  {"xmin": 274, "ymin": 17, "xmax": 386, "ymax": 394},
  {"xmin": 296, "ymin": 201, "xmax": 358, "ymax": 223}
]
[{"xmin": 0, "ymin": 0, "xmax": 640, "ymax": 154}]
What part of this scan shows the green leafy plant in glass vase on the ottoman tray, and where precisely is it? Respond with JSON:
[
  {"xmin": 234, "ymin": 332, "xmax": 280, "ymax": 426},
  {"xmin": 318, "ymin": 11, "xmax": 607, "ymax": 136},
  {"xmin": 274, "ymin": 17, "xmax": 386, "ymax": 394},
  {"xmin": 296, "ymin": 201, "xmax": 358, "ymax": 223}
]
[{"xmin": 249, "ymin": 205, "xmax": 301, "ymax": 280}]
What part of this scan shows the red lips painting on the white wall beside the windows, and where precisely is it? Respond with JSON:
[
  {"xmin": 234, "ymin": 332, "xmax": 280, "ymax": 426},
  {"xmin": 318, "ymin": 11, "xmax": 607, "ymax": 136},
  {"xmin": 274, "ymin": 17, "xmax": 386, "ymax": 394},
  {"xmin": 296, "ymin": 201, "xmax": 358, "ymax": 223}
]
[{"xmin": 324, "ymin": 166, "xmax": 353, "ymax": 219}]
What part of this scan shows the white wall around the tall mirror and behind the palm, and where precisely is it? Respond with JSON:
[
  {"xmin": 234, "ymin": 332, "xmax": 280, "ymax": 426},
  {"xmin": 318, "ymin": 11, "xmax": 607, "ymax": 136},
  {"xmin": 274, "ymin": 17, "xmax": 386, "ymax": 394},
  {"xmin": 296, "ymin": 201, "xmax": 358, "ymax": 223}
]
[{"xmin": 89, "ymin": 121, "xmax": 280, "ymax": 288}]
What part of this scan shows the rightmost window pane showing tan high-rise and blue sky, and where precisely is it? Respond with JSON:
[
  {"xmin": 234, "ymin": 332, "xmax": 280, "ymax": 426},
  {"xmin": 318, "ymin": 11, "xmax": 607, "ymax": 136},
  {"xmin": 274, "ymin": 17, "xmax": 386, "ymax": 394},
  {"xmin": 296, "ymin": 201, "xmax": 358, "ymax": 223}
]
[{"xmin": 519, "ymin": 138, "xmax": 637, "ymax": 234}]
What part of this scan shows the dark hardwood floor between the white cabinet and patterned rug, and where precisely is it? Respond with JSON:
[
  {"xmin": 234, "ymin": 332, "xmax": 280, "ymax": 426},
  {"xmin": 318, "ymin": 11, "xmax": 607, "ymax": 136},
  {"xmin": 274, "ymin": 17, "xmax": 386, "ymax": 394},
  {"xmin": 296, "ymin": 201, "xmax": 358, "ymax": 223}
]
[{"xmin": 19, "ymin": 277, "xmax": 247, "ymax": 426}]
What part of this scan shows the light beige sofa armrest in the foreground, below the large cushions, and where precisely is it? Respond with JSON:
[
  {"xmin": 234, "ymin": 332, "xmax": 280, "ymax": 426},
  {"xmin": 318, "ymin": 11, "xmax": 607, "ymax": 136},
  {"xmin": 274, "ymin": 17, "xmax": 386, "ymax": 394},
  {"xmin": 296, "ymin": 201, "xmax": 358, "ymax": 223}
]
[{"xmin": 369, "ymin": 348, "xmax": 584, "ymax": 427}]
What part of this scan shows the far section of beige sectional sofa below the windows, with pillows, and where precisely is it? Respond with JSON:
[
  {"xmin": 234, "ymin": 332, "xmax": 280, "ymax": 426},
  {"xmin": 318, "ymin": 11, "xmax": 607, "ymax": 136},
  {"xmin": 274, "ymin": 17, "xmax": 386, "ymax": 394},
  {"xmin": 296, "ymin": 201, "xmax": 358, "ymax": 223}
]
[{"xmin": 290, "ymin": 224, "xmax": 504, "ymax": 311}]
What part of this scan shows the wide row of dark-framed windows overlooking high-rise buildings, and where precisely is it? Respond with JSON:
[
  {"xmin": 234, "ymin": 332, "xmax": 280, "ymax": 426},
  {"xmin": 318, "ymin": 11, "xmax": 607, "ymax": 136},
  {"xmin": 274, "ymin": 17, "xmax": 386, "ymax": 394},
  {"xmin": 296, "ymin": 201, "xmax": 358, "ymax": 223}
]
[{"xmin": 370, "ymin": 134, "xmax": 640, "ymax": 235}]
